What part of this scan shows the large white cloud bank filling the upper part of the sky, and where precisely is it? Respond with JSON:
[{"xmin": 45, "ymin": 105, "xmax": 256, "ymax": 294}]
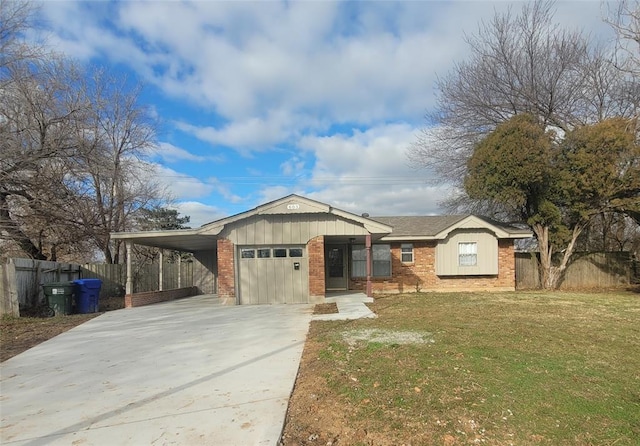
[{"xmin": 38, "ymin": 1, "xmax": 600, "ymax": 153}]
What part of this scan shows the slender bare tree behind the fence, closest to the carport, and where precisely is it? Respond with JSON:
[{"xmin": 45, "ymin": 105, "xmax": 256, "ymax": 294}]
[{"xmin": 68, "ymin": 69, "xmax": 166, "ymax": 263}]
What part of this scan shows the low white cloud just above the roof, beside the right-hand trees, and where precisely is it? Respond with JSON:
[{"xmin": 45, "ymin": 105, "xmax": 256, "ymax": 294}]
[{"xmin": 301, "ymin": 123, "xmax": 443, "ymax": 215}]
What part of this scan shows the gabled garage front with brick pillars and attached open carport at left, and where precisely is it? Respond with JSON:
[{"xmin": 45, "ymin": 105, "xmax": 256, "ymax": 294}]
[{"xmin": 111, "ymin": 195, "xmax": 392, "ymax": 305}]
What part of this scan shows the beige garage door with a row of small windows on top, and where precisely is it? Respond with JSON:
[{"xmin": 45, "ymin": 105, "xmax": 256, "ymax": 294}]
[{"xmin": 237, "ymin": 246, "xmax": 309, "ymax": 305}]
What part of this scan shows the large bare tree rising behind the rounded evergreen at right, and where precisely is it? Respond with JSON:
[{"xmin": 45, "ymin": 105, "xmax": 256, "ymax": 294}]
[{"xmin": 408, "ymin": 1, "xmax": 637, "ymax": 193}]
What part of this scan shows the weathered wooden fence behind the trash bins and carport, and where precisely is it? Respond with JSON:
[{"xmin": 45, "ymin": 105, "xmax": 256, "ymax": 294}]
[{"xmin": 0, "ymin": 259, "xmax": 193, "ymax": 316}]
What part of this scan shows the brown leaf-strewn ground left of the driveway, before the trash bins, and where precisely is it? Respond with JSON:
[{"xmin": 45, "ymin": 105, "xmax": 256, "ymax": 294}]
[{"xmin": 0, "ymin": 313, "xmax": 101, "ymax": 362}]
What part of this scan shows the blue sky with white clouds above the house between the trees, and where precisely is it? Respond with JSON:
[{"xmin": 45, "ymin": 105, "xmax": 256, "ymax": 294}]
[{"xmin": 40, "ymin": 0, "xmax": 610, "ymax": 227}]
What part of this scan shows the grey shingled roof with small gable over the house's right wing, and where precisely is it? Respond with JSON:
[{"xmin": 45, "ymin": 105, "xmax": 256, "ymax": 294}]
[{"xmin": 371, "ymin": 214, "xmax": 533, "ymax": 240}]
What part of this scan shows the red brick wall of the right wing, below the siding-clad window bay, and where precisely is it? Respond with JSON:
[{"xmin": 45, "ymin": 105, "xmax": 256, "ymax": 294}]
[{"xmin": 349, "ymin": 240, "xmax": 515, "ymax": 293}]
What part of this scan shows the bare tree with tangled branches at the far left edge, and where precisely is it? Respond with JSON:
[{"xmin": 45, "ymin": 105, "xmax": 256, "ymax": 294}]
[{"xmin": 0, "ymin": 58, "xmax": 86, "ymax": 259}]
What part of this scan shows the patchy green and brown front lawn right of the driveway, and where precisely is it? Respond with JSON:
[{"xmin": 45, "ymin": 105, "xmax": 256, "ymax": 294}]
[{"xmin": 315, "ymin": 292, "xmax": 640, "ymax": 445}]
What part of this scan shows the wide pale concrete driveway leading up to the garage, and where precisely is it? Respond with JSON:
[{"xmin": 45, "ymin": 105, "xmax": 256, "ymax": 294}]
[{"xmin": 0, "ymin": 296, "xmax": 312, "ymax": 446}]
